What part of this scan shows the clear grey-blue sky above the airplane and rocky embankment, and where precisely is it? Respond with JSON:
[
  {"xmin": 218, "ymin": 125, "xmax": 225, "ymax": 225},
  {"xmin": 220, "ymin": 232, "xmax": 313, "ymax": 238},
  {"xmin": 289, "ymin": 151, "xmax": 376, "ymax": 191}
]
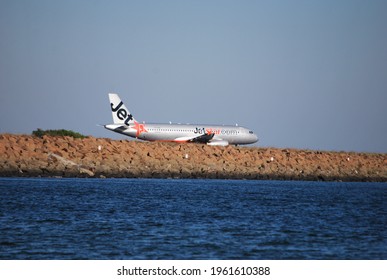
[{"xmin": 0, "ymin": 0, "xmax": 387, "ymax": 153}]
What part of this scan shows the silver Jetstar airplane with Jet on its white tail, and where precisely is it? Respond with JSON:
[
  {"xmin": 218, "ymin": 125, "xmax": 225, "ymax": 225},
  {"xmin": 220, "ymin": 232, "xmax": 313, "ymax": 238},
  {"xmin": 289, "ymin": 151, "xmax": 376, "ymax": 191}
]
[{"xmin": 104, "ymin": 93, "xmax": 258, "ymax": 146}]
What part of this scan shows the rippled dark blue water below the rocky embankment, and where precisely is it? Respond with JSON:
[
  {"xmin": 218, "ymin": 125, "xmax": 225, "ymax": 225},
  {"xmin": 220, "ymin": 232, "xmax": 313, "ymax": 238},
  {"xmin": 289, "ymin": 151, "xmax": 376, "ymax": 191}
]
[{"xmin": 0, "ymin": 178, "xmax": 387, "ymax": 259}]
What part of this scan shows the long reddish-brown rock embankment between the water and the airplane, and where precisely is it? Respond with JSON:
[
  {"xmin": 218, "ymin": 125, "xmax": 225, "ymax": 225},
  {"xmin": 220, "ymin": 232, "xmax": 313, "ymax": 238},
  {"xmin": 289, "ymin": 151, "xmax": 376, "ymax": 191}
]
[{"xmin": 0, "ymin": 134, "xmax": 387, "ymax": 182}]
